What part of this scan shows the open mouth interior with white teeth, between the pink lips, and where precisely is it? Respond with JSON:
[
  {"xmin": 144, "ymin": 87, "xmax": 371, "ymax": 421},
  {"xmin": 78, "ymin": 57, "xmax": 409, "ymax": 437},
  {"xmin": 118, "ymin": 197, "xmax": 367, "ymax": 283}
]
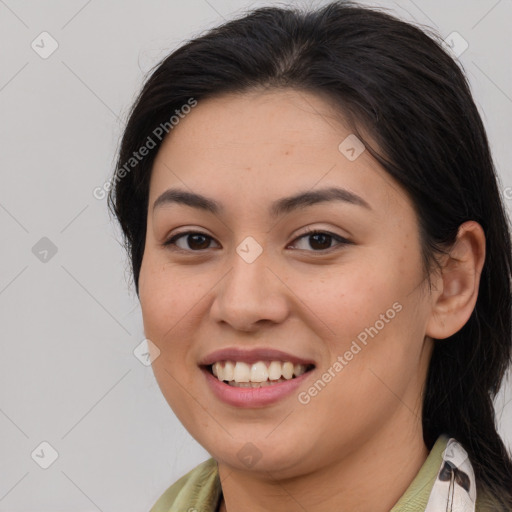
[{"xmin": 201, "ymin": 359, "xmax": 315, "ymax": 388}]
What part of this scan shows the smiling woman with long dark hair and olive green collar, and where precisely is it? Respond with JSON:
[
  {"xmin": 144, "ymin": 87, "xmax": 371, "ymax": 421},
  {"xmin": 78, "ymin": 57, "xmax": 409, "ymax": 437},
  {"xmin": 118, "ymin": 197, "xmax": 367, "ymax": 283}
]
[{"xmin": 110, "ymin": 2, "xmax": 512, "ymax": 512}]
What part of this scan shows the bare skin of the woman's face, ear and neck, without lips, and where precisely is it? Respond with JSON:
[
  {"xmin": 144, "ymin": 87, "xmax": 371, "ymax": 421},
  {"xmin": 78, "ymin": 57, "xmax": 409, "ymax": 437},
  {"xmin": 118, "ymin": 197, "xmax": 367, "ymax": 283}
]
[{"xmin": 139, "ymin": 90, "xmax": 485, "ymax": 512}]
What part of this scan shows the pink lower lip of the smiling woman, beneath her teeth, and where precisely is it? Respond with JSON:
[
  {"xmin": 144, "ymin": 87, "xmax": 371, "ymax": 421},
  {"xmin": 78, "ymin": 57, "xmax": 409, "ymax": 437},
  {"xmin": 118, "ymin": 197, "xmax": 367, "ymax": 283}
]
[{"xmin": 201, "ymin": 368, "xmax": 313, "ymax": 408}]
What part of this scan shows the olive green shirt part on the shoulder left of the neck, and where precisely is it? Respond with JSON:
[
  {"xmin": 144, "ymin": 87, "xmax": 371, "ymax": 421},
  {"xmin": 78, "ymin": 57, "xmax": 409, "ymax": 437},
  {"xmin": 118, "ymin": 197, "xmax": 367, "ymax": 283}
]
[{"xmin": 150, "ymin": 458, "xmax": 221, "ymax": 512}]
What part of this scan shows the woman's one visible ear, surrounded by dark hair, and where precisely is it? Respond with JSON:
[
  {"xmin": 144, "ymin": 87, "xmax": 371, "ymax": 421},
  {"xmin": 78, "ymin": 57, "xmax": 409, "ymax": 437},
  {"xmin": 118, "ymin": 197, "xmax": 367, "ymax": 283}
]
[{"xmin": 425, "ymin": 221, "xmax": 485, "ymax": 339}]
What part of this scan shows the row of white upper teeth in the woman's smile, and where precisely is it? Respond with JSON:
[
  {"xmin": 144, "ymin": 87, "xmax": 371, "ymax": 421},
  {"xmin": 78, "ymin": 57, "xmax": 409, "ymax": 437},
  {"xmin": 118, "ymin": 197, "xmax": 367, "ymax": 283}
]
[{"xmin": 212, "ymin": 361, "xmax": 306, "ymax": 382}]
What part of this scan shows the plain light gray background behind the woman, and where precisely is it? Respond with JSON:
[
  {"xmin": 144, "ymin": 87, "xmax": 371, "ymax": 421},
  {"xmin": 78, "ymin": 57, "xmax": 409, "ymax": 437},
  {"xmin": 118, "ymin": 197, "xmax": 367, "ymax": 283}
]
[{"xmin": 0, "ymin": 0, "xmax": 512, "ymax": 512}]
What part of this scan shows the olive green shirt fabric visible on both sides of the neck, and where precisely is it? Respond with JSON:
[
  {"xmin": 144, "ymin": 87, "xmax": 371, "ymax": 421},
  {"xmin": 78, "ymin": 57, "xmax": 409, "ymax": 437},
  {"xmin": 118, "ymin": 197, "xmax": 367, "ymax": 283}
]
[{"xmin": 150, "ymin": 435, "xmax": 495, "ymax": 512}]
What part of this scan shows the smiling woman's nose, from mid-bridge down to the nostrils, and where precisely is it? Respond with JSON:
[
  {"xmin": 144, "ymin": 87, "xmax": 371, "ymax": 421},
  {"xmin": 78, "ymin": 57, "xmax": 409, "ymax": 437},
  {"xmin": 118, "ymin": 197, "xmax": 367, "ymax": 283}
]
[{"xmin": 210, "ymin": 243, "xmax": 289, "ymax": 332}]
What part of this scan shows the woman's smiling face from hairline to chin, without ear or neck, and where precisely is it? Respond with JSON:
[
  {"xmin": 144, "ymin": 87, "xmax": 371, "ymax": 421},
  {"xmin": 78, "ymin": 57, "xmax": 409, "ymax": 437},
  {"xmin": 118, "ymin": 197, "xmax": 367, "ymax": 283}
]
[{"xmin": 139, "ymin": 90, "xmax": 432, "ymax": 476}]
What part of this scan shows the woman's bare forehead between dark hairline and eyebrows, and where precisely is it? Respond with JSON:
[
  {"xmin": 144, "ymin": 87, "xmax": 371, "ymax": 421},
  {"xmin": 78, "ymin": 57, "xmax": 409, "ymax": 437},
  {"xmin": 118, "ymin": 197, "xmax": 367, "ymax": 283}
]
[{"xmin": 150, "ymin": 90, "xmax": 407, "ymax": 216}]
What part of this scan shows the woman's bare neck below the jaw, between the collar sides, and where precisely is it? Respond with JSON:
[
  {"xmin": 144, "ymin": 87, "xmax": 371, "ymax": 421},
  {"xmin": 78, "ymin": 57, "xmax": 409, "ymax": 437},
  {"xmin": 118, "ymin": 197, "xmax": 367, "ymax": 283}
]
[{"xmin": 219, "ymin": 422, "xmax": 428, "ymax": 512}]
